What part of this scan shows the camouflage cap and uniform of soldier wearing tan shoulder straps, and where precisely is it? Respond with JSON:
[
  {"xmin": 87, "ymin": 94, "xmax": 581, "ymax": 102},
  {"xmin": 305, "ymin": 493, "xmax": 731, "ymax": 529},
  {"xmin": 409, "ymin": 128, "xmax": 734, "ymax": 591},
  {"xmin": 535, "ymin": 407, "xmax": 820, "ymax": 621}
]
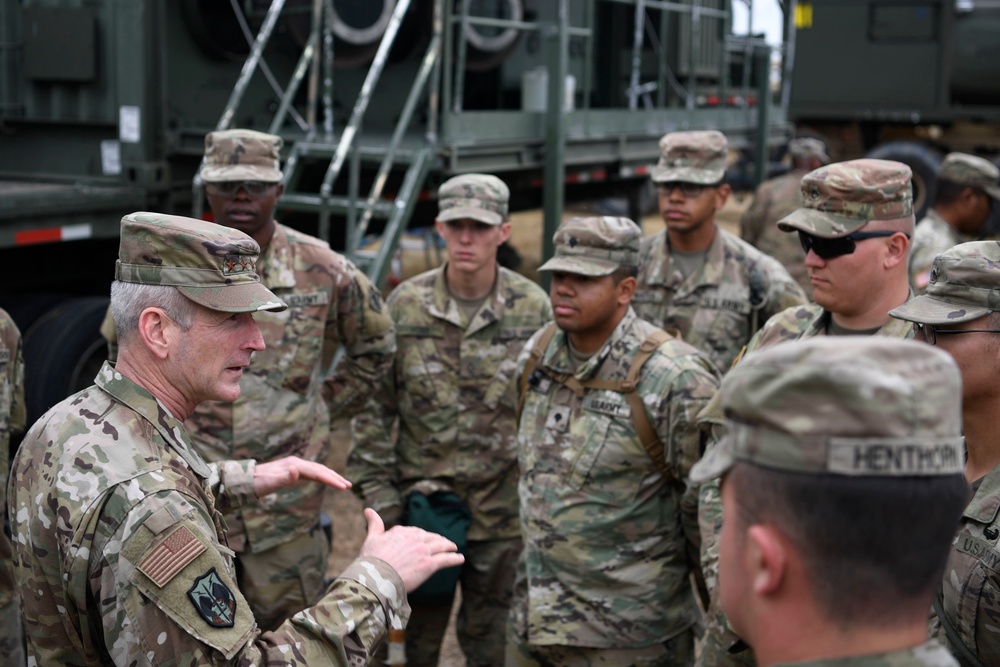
[{"xmin": 507, "ymin": 218, "xmax": 718, "ymax": 665}]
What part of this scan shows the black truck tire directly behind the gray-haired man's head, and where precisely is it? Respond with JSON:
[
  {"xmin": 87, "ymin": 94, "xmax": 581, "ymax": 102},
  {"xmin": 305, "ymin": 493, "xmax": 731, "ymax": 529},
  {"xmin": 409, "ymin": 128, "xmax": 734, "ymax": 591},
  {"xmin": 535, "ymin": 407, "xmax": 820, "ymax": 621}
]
[{"xmin": 24, "ymin": 297, "xmax": 108, "ymax": 424}]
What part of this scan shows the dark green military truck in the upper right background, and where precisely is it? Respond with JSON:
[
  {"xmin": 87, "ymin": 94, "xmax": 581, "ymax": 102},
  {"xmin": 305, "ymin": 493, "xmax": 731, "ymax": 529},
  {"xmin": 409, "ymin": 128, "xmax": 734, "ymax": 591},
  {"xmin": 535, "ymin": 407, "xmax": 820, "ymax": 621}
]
[{"xmin": 788, "ymin": 0, "xmax": 1000, "ymax": 213}]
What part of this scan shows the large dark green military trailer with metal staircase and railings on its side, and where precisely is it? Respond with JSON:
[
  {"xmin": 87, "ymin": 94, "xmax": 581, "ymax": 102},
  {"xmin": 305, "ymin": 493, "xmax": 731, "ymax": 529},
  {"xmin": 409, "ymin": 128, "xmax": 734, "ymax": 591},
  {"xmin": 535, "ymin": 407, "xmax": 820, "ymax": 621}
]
[{"xmin": 0, "ymin": 0, "xmax": 788, "ymax": 426}]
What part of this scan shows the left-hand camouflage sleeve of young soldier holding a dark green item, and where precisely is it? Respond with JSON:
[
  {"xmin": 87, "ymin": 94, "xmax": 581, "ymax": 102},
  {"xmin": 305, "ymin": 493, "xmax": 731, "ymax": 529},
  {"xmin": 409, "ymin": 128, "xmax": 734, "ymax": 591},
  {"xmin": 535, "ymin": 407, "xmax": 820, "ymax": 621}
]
[{"xmin": 347, "ymin": 374, "xmax": 403, "ymax": 528}]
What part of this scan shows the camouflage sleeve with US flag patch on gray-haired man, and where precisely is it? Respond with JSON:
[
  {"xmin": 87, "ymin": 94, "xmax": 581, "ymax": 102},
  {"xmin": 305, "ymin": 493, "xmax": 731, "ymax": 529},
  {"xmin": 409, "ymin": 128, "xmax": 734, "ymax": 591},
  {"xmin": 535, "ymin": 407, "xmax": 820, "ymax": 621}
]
[{"xmin": 97, "ymin": 490, "xmax": 409, "ymax": 665}]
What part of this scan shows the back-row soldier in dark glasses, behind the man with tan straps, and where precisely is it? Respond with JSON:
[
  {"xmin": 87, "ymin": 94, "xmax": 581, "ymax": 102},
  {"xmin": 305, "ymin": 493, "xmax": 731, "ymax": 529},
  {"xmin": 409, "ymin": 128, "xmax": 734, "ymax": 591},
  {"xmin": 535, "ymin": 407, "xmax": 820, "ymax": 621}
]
[{"xmin": 632, "ymin": 130, "xmax": 807, "ymax": 372}]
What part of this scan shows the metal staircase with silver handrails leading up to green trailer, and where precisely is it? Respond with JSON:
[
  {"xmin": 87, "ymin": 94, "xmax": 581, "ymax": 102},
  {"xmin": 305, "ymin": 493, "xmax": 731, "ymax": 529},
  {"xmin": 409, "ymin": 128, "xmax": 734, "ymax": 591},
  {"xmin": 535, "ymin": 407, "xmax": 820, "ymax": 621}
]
[{"xmin": 194, "ymin": 0, "xmax": 441, "ymax": 284}]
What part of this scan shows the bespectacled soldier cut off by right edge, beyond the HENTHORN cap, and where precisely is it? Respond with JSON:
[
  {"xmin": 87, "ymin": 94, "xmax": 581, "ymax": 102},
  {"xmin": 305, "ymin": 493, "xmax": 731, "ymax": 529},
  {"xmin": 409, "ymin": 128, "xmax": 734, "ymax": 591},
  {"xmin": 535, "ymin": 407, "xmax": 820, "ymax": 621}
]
[{"xmin": 890, "ymin": 241, "xmax": 1000, "ymax": 665}]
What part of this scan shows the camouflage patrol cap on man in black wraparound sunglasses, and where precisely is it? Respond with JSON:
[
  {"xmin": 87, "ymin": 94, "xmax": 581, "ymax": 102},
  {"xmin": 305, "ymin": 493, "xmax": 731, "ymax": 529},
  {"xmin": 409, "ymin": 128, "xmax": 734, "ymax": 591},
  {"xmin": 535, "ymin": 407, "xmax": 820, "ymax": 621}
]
[{"xmin": 778, "ymin": 158, "xmax": 913, "ymax": 239}]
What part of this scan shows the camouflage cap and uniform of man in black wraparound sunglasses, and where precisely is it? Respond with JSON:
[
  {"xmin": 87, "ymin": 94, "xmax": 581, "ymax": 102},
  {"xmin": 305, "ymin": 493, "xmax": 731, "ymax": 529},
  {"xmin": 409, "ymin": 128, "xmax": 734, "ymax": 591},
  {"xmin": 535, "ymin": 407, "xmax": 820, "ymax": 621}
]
[{"xmin": 698, "ymin": 160, "xmax": 914, "ymax": 667}]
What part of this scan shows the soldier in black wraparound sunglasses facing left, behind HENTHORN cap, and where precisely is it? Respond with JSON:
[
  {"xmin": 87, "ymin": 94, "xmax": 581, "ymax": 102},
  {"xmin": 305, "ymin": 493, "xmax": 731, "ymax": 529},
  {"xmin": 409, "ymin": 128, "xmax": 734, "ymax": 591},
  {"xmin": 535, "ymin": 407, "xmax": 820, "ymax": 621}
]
[{"xmin": 698, "ymin": 159, "xmax": 914, "ymax": 665}]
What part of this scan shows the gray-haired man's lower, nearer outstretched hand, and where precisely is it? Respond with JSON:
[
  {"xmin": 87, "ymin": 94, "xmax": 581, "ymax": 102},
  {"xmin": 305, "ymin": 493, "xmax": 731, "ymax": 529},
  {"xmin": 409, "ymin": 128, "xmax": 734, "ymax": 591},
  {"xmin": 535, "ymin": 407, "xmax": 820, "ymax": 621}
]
[{"xmin": 361, "ymin": 508, "xmax": 465, "ymax": 593}]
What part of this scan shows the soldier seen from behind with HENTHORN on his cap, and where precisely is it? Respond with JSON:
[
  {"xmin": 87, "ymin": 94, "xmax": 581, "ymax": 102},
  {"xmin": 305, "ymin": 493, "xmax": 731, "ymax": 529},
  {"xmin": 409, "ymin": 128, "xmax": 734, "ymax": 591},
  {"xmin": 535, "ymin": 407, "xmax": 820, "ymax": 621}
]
[{"xmin": 691, "ymin": 336, "xmax": 964, "ymax": 667}]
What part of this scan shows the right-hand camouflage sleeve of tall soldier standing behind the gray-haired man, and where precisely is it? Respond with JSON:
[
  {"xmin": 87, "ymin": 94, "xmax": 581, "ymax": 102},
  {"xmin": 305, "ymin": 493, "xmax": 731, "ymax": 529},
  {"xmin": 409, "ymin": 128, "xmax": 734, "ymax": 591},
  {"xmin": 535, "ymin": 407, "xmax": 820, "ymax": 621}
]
[{"xmin": 323, "ymin": 260, "xmax": 396, "ymax": 418}]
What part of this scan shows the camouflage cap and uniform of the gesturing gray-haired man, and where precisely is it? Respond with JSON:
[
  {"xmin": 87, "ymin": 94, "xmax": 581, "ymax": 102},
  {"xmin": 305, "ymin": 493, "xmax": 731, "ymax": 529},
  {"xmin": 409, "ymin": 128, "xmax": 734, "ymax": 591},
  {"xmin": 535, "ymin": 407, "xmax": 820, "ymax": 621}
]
[{"xmin": 10, "ymin": 213, "xmax": 409, "ymax": 665}]
